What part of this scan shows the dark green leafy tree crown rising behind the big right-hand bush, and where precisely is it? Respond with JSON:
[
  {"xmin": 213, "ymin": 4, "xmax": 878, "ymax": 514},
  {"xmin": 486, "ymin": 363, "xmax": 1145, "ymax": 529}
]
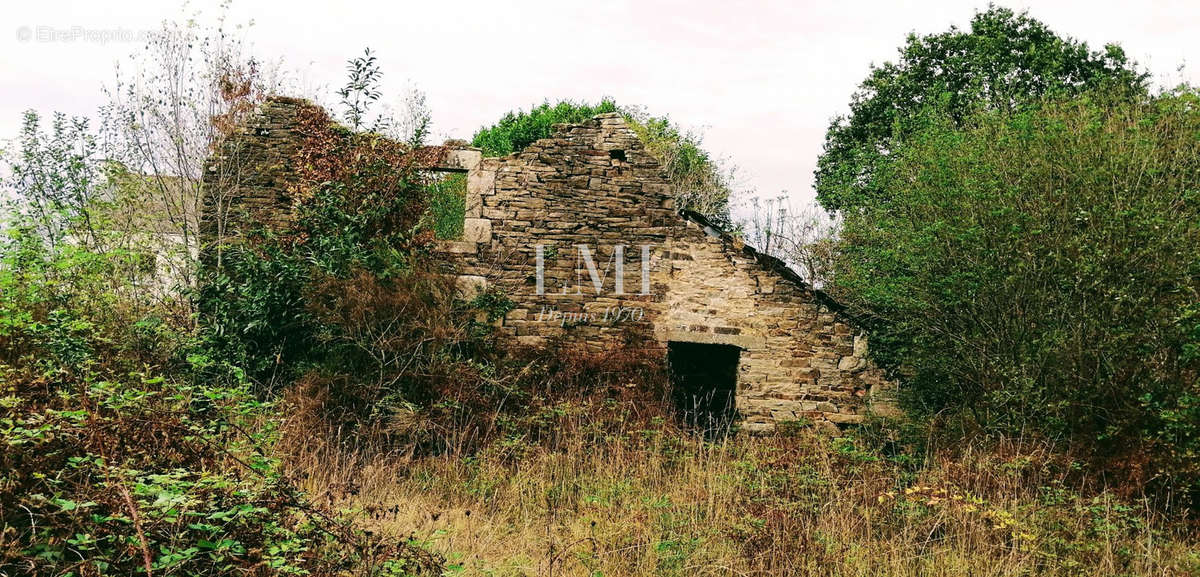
[{"xmin": 816, "ymin": 6, "xmax": 1147, "ymax": 211}]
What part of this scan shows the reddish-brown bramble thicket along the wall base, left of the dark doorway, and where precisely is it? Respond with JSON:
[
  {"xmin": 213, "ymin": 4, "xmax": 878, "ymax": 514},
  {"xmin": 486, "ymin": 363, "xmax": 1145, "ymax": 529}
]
[{"xmin": 284, "ymin": 292, "xmax": 670, "ymax": 456}]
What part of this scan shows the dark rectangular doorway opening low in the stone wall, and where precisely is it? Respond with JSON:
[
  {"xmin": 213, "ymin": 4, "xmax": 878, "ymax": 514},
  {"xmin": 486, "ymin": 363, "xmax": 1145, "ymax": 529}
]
[{"xmin": 667, "ymin": 341, "xmax": 742, "ymax": 432}]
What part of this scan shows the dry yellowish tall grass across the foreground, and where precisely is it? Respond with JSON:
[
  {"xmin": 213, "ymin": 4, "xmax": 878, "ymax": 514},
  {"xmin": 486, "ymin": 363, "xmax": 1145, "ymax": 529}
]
[{"xmin": 278, "ymin": 404, "xmax": 1200, "ymax": 576}]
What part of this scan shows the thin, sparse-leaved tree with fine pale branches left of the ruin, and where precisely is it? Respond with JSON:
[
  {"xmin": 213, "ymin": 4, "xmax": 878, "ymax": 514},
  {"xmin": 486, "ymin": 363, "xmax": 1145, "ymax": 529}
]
[{"xmin": 100, "ymin": 15, "xmax": 270, "ymax": 286}]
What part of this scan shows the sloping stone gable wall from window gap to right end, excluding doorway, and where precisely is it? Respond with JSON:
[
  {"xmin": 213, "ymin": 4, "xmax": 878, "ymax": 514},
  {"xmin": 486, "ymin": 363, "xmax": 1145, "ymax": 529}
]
[{"xmin": 448, "ymin": 114, "xmax": 889, "ymax": 431}]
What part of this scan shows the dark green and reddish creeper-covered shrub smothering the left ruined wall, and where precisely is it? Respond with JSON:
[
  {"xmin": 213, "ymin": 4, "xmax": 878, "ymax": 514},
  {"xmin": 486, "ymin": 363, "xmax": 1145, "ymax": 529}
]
[{"xmin": 198, "ymin": 107, "xmax": 433, "ymax": 392}]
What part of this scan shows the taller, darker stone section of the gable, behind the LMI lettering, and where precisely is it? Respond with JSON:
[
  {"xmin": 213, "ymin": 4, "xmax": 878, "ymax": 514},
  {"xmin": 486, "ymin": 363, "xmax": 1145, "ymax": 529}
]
[{"xmin": 454, "ymin": 115, "xmax": 682, "ymax": 348}]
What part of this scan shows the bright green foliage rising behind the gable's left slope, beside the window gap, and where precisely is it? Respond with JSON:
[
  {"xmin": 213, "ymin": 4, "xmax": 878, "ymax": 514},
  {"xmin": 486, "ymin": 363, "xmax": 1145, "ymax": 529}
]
[{"xmin": 470, "ymin": 98, "xmax": 618, "ymax": 156}]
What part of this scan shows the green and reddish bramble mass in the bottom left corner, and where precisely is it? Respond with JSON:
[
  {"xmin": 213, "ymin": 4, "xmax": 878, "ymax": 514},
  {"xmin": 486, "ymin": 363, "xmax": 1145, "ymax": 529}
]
[{"xmin": 0, "ymin": 226, "xmax": 439, "ymax": 576}]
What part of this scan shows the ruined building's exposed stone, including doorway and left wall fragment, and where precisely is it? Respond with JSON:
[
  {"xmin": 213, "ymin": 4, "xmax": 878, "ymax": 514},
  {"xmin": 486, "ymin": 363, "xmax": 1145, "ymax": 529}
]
[{"xmin": 206, "ymin": 98, "xmax": 893, "ymax": 432}]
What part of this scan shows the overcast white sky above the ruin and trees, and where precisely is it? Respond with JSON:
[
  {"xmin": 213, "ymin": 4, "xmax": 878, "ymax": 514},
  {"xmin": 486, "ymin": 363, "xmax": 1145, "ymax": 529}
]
[{"xmin": 0, "ymin": 0, "xmax": 1200, "ymax": 208}]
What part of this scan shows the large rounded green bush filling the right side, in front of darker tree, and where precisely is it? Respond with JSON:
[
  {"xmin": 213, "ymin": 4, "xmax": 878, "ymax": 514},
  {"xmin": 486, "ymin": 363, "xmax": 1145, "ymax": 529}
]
[{"xmin": 836, "ymin": 90, "xmax": 1200, "ymax": 499}]
